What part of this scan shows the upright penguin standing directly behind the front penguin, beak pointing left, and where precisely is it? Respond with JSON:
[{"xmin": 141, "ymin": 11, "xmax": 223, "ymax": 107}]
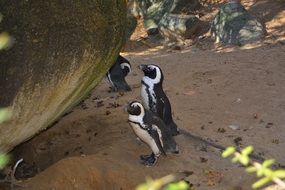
[{"xmin": 139, "ymin": 64, "xmax": 179, "ymax": 136}]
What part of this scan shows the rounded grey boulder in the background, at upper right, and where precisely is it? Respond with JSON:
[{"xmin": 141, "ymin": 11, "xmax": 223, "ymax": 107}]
[{"xmin": 211, "ymin": 1, "xmax": 265, "ymax": 45}]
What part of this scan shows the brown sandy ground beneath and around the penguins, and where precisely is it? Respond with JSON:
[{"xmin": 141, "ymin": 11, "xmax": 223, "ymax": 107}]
[{"xmin": 0, "ymin": 1, "xmax": 285, "ymax": 190}]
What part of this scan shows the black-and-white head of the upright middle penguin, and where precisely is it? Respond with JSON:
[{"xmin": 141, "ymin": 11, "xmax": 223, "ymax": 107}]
[{"xmin": 139, "ymin": 64, "xmax": 163, "ymax": 84}]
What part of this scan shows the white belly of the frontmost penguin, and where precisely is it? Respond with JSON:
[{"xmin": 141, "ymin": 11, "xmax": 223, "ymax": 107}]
[{"xmin": 130, "ymin": 123, "xmax": 160, "ymax": 154}]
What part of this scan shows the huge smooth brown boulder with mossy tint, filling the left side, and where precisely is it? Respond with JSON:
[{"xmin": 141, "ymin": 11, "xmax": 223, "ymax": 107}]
[{"xmin": 0, "ymin": 0, "xmax": 127, "ymax": 152}]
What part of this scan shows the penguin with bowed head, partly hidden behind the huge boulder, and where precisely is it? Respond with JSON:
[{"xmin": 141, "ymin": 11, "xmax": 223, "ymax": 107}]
[{"xmin": 106, "ymin": 55, "xmax": 132, "ymax": 91}]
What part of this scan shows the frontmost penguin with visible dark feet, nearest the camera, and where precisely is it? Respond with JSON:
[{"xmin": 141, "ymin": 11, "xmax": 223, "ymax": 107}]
[{"xmin": 127, "ymin": 101, "xmax": 179, "ymax": 167}]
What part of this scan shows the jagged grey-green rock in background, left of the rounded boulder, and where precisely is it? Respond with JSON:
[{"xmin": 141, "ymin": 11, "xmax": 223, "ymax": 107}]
[{"xmin": 134, "ymin": 0, "xmax": 202, "ymax": 41}]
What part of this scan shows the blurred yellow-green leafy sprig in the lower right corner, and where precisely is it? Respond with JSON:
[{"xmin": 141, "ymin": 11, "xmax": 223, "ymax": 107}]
[{"xmin": 222, "ymin": 146, "xmax": 285, "ymax": 189}]
